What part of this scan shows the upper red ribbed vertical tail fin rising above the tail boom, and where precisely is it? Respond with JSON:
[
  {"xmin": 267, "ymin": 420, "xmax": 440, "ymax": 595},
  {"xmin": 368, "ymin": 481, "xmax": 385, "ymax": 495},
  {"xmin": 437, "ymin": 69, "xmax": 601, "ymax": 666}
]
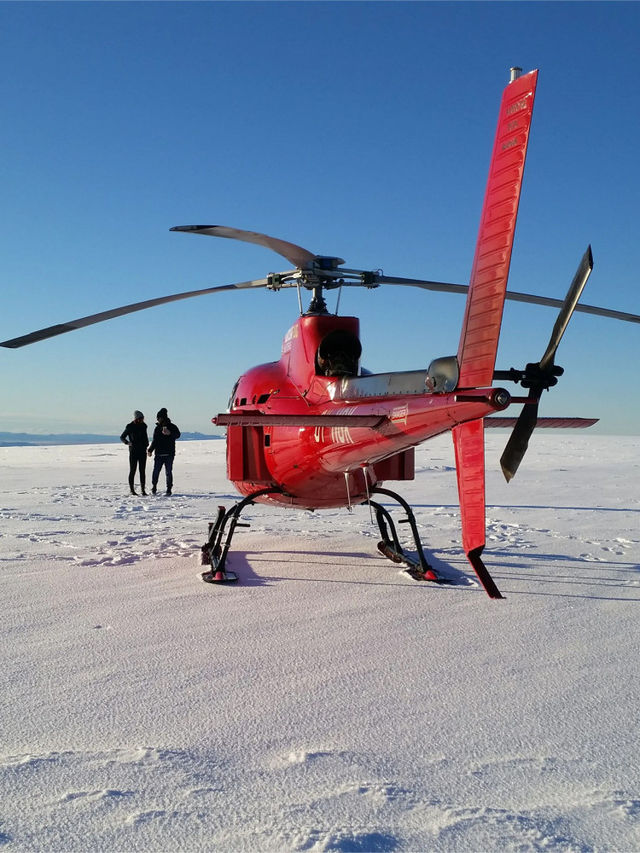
[{"xmin": 458, "ymin": 71, "xmax": 538, "ymax": 388}]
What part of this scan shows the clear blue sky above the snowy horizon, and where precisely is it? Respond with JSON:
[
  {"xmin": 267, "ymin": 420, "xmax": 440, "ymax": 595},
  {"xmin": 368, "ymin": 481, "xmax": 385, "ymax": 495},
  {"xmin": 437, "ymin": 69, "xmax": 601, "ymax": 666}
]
[{"xmin": 0, "ymin": 2, "xmax": 640, "ymax": 433}]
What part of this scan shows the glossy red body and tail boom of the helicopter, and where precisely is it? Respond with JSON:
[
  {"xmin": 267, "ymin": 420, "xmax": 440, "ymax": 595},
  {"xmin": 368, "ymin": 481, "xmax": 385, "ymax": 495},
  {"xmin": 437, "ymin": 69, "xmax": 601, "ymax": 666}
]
[{"xmin": 220, "ymin": 314, "xmax": 510, "ymax": 509}]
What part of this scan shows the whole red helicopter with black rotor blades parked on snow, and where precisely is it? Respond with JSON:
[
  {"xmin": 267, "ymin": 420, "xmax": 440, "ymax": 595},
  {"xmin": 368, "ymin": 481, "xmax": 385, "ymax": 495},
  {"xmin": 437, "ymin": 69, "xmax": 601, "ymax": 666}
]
[{"xmin": 0, "ymin": 68, "xmax": 640, "ymax": 598}]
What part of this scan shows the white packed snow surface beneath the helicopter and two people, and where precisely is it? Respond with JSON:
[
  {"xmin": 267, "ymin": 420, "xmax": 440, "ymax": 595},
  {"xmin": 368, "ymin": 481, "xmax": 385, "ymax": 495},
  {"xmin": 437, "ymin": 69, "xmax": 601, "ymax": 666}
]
[{"xmin": 0, "ymin": 432, "xmax": 640, "ymax": 853}]
